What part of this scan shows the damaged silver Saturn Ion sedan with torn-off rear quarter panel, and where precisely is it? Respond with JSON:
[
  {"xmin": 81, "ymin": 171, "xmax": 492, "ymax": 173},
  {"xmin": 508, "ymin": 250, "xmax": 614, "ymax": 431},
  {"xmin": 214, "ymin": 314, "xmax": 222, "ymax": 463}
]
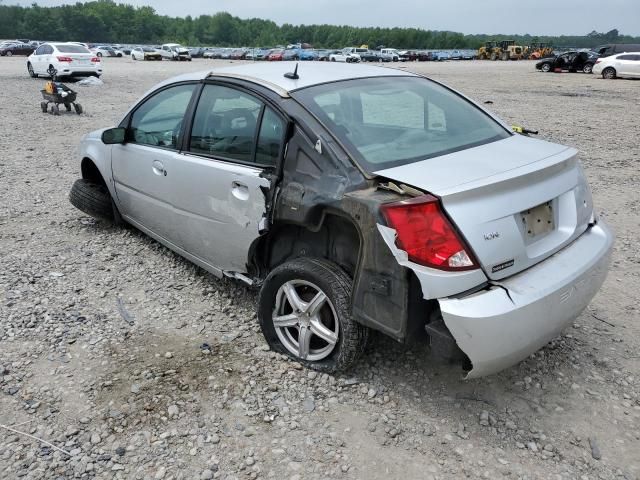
[{"xmin": 70, "ymin": 62, "xmax": 613, "ymax": 377}]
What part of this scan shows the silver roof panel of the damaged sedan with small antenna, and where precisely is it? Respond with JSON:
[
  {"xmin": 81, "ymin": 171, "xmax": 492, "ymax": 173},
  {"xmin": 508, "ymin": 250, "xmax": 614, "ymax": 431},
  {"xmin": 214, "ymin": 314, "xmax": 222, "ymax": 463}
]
[{"xmin": 161, "ymin": 62, "xmax": 420, "ymax": 97}]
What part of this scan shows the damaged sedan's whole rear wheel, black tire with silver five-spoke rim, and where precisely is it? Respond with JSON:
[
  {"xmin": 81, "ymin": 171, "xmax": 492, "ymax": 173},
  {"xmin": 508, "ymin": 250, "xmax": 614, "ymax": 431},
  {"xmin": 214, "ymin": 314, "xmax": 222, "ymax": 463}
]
[{"xmin": 258, "ymin": 258, "xmax": 369, "ymax": 372}]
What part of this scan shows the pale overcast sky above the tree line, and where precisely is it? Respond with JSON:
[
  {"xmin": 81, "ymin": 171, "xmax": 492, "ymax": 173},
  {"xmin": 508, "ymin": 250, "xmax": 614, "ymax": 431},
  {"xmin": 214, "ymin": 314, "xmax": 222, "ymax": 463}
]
[{"xmin": 8, "ymin": 0, "xmax": 640, "ymax": 35}]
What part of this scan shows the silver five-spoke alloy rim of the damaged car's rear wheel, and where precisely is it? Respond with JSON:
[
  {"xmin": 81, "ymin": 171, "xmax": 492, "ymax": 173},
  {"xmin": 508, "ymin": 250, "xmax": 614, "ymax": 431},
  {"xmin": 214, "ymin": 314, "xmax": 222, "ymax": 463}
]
[{"xmin": 272, "ymin": 280, "xmax": 340, "ymax": 362}]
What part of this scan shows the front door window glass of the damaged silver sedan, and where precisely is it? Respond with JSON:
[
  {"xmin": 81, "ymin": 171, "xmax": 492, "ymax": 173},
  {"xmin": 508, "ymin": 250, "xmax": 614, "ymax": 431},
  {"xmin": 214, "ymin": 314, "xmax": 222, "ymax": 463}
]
[{"xmin": 128, "ymin": 84, "xmax": 195, "ymax": 150}]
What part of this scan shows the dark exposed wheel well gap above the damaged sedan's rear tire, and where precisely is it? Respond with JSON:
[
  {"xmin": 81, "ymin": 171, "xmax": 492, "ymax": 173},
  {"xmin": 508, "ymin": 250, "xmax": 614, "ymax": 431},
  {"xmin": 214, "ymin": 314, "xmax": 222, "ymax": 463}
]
[{"xmin": 252, "ymin": 214, "xmax": 361, "ymax": 278}]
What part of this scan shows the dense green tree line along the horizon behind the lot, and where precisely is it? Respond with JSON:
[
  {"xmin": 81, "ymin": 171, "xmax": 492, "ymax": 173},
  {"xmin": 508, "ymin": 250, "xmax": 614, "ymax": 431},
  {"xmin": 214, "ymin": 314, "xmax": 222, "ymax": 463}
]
[{"xmin": 0, "ymin": 0, "xmax": 640, "ymax": 49}]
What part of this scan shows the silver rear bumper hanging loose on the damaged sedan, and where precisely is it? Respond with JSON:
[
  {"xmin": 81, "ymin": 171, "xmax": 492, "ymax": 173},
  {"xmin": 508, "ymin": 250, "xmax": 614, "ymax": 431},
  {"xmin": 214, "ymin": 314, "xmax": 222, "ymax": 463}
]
[{"xmin": 438, "ymin": 222, "xmax": 613, "ymax": 378}]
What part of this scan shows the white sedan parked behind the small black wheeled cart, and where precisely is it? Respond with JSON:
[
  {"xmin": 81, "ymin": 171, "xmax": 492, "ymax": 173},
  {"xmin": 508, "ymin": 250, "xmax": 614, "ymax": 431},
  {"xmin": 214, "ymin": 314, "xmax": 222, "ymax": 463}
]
[{"xmin": 27, "ymin": 43, "xmax": 102, "ymax": 78}]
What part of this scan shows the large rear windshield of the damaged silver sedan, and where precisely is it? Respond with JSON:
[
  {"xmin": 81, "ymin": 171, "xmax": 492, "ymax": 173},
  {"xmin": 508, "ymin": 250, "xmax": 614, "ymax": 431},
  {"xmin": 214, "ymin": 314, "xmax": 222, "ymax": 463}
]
[{"xmin": 294, "ymin": 77, "xmax": 510, "ymax": 173}]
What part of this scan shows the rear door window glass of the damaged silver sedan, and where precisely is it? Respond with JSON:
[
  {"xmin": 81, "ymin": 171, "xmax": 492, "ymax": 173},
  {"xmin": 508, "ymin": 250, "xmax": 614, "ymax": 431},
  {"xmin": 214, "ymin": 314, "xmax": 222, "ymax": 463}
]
[{"xmin": 190, "ymin": 85, "xmax": 263, "ymax": 162}]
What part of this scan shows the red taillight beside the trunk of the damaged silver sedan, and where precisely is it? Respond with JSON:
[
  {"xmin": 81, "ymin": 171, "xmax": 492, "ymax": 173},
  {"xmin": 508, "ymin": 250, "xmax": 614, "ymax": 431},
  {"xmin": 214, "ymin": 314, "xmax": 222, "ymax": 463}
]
[{"xmin": 381, "ymin": 195, "xmax": 478, "ymax": 270}]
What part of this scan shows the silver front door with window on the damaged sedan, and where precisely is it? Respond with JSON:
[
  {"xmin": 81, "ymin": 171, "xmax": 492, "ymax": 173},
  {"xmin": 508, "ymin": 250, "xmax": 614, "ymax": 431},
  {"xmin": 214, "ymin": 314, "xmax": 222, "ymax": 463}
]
[{"xmin": 111, "ymin": 83, "xmax": 196, "ymax": 246}]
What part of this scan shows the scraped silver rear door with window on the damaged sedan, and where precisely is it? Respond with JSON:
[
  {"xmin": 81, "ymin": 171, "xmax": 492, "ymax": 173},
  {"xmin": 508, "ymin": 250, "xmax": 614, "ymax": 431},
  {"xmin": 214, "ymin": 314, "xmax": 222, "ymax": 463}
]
[{"xmin": 174, "ymin": 83, "xmax": 286, "ymax": 273}]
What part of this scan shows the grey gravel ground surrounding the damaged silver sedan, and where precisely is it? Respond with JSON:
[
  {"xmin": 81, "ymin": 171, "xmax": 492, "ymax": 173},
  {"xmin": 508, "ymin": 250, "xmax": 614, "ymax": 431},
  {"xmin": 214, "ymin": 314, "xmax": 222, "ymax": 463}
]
[{"xmin": 0, "ymin": 58, "xmax": 640, "ymax": 480}]
